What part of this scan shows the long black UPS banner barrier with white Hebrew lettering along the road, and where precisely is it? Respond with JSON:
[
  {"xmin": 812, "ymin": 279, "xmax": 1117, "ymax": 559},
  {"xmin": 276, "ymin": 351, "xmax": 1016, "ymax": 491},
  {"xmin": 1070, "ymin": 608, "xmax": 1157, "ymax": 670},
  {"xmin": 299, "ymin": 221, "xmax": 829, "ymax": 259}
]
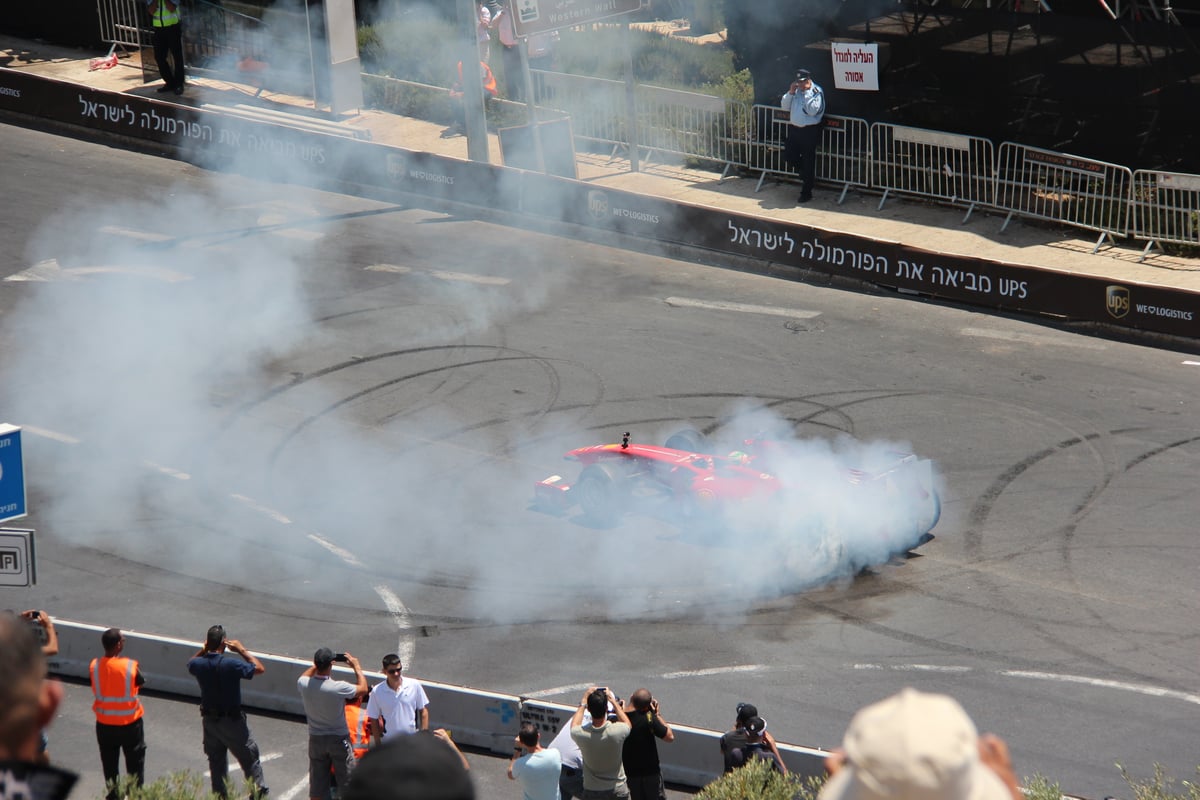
[{"xmin": 0, "ymin": 68, "xmax": 1200, "ymax": 338}]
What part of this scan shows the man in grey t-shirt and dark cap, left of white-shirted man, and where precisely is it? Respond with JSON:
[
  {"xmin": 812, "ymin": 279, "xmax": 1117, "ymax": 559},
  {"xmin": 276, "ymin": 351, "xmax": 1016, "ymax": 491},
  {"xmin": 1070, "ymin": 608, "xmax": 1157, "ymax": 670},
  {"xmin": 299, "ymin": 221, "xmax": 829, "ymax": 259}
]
[{"xmin": 296, "ymin": 648, "xmax": 370, "ymax": 800}]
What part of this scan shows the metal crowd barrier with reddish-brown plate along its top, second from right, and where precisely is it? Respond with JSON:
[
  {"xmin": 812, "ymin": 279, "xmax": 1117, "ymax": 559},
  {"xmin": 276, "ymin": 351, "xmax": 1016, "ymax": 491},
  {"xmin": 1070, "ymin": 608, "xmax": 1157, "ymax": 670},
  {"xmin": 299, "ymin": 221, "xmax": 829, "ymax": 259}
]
[{"xmin": 995, "ymin": 142, "xmax": 1133, "ymax": 253}]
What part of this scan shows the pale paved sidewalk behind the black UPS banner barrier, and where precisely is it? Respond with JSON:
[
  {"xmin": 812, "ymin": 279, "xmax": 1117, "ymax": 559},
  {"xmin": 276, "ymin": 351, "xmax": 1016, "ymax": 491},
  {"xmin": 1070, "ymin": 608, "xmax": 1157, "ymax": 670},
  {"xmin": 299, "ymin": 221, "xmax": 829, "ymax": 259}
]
[{"xmin": 0, "ymin": 35, "xmax": 1200, "ymax": 303}]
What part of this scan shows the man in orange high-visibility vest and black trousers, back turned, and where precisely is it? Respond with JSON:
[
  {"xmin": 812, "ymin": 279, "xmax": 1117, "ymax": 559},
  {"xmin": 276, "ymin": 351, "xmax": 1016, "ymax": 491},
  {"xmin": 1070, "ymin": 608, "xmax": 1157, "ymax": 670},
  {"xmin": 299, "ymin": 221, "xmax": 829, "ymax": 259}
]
[{"xmin": 88, "ymin": 627, "xmax": 146, "ymax": 800}]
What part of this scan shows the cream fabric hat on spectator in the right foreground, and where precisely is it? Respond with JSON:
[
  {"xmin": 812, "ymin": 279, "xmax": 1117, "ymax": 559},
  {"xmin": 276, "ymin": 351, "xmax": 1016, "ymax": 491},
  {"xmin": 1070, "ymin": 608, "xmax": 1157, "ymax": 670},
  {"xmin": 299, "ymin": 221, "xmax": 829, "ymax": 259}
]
[{"xmin": 817, "ymin": 688, "xmax": 1012, "ymax": 800}]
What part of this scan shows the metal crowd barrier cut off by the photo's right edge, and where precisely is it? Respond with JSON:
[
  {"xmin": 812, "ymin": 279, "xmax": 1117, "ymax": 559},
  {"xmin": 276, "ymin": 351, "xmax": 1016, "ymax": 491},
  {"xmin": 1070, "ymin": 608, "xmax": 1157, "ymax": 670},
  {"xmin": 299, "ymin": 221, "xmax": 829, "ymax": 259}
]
[{"xmin": 1129, "ymin": 169, "xmax": 1200, "ymax": 260}]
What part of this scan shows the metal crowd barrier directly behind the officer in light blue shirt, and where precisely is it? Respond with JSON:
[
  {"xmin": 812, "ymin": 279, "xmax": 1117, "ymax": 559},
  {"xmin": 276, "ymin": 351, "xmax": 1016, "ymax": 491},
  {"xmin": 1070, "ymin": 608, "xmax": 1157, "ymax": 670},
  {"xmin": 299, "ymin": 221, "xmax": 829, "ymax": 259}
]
[{"xmin": 743, "ymin": 104, "xmax": 870, "ymax": 205}]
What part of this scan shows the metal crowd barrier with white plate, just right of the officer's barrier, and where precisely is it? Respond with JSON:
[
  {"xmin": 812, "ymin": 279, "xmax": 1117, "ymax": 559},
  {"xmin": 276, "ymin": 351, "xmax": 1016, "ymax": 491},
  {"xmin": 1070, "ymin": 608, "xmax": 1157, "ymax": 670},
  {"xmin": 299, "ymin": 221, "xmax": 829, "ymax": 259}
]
[{"xmin": 871, "ymin": 122, "xmax": 995, "ymax": 222}]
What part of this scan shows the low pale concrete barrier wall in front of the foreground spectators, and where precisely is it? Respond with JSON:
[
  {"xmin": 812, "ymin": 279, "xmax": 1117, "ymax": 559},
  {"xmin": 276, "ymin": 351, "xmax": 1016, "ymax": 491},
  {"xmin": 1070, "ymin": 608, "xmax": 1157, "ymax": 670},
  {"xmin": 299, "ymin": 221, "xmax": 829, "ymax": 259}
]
[{"xmin": 49, "ymin": 619, "xmax": 827, "ymax": 788}]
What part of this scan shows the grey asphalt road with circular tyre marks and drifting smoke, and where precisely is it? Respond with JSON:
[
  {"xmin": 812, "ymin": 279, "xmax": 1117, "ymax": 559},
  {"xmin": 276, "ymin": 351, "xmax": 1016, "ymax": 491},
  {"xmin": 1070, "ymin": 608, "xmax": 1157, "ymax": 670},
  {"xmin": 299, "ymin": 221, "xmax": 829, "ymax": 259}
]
[{"xmin": 0, "ymin": 120, "xmax": 1200, "ymax": 798}]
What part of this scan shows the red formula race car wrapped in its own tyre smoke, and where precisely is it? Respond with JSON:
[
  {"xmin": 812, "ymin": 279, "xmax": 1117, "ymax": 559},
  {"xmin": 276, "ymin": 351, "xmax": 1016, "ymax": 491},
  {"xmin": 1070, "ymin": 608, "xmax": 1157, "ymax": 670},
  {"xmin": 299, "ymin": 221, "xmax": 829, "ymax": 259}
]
[{"xmin": 534, "ymin": 429, "xmax": 941, "ymax": 566}]
